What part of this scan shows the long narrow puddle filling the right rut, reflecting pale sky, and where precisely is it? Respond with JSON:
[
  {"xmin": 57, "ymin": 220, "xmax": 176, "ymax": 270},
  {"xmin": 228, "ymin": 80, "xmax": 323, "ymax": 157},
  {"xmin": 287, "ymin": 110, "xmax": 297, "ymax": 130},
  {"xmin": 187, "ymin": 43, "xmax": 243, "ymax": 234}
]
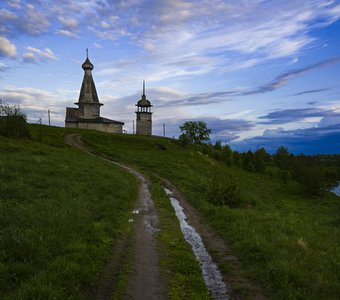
[{"xmin": 164, "ymin": 188, "xmax": 228, "ymax": 300}]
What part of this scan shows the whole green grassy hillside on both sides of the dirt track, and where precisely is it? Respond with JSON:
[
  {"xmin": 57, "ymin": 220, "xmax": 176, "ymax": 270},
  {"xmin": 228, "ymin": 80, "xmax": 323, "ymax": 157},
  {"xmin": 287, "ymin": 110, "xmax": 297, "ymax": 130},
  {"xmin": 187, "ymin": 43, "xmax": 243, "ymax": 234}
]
[{"xmin": 0, "ymin": 126, "xmax": 340, "ymax": 299}]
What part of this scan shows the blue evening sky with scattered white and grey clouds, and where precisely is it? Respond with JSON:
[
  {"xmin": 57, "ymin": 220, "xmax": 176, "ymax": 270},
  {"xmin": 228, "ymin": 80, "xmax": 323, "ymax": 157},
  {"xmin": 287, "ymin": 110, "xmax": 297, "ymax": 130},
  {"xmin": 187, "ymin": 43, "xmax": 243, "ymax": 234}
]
[{"xmin": 0, "ymin": 0, "xmax": 340, "ymax": 154}]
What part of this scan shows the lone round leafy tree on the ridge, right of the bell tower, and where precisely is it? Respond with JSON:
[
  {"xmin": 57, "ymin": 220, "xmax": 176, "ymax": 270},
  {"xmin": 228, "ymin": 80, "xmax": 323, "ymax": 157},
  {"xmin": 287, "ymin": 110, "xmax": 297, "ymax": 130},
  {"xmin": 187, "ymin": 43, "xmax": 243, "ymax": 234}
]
[{"xmin": 179, "ymin": 121, "xmax": 211, "ymax": 144}]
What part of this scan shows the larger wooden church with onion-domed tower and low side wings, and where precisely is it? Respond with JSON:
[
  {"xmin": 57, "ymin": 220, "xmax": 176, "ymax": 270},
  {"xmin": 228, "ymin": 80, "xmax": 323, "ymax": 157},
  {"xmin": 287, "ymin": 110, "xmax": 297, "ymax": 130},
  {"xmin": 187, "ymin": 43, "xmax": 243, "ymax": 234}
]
[{"xmin": 65, "ymin": 50, "xmax": 124, "ymax": 133}]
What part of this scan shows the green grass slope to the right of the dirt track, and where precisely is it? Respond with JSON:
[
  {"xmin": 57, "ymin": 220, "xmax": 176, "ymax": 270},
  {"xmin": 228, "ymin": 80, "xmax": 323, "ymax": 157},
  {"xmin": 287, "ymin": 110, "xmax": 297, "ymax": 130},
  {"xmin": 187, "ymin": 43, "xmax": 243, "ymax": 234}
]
[{"xmin": 84, "ymin": 132, "xmax": 340, "ymax": 299}]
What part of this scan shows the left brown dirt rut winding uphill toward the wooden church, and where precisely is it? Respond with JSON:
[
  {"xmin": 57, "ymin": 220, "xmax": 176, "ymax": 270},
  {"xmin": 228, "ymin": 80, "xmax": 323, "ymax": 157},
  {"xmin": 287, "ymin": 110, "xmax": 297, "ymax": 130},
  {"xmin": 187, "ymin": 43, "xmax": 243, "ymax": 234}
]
[{"xmin": 65, "ymin": 134, "xmax": 166, "ymax": 300}]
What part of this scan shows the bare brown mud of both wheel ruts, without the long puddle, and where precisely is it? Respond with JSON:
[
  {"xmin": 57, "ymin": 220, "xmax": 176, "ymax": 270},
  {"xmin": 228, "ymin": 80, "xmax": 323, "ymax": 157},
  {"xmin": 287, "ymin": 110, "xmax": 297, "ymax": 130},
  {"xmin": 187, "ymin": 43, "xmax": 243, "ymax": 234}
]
[{"xmin": 66, "ymin": 134, "xmax": 268, "ymax": 300}]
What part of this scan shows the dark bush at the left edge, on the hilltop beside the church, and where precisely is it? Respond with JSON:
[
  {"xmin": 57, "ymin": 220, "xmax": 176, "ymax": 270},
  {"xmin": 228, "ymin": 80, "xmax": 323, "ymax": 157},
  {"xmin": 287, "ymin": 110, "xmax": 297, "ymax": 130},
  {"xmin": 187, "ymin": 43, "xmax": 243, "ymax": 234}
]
[{"xmin": 0, "ymin": 105, "xmax": 30, "ymax": 138}]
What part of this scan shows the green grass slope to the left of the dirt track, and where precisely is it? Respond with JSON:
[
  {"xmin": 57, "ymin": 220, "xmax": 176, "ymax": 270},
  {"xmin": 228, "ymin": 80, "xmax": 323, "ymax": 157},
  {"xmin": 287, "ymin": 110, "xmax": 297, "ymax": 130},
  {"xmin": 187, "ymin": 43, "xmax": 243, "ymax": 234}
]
[{"xmin": 0, "ymin": 126, "xmax": 138, "ymax": 299}]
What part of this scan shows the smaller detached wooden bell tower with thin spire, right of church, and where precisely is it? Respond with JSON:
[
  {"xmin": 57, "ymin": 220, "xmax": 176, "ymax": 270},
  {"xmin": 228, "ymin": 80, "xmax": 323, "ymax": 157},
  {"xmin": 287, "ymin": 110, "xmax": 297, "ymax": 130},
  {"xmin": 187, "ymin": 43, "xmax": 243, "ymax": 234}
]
[{"xmin": 136, "ymin": 80, "xmax": 152, "ymax": 135}]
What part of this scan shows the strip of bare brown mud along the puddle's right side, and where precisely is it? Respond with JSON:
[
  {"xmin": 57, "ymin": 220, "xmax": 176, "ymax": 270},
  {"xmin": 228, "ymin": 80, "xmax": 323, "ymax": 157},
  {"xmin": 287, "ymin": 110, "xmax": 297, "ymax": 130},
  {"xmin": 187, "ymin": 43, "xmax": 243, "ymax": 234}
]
[{"xmin": 163, "ymin": 180, "xmax": 268, "ymax": 300}]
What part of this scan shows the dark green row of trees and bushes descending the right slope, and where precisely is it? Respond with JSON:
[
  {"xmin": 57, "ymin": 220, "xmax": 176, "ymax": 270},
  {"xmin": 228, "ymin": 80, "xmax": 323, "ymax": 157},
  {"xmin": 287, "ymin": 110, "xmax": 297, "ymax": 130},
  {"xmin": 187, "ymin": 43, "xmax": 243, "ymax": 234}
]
[{"xmin": 179, "ymin": 121, "xmax": 340, "ymax": 195}]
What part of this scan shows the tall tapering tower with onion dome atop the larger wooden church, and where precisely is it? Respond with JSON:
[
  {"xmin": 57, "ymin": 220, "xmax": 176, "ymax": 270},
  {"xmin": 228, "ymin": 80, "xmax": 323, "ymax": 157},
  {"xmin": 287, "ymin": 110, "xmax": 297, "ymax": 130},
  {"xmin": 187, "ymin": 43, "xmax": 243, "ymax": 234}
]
[{"xmin": 75, "ymin": 49, "xmax": 103, "ymax": 119}]
